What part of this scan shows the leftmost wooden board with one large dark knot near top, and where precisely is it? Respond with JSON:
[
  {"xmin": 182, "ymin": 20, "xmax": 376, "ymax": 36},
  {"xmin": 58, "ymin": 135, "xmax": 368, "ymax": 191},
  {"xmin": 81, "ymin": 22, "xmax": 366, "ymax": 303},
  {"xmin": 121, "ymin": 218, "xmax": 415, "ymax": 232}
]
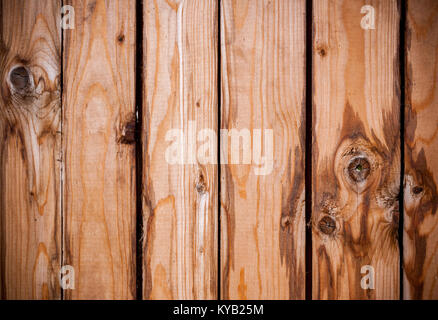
[{"xmin": 0, "ymin": 0, "xmax": 61, "ymax": 299}]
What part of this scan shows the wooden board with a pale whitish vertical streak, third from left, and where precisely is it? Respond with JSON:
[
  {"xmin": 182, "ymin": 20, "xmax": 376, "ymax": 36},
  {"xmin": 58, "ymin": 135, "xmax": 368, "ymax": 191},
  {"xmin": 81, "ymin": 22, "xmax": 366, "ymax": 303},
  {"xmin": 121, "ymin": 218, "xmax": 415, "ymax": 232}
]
[{"xmin": 142, "ymin": 0, "xmax": 218, "ymax": 299}]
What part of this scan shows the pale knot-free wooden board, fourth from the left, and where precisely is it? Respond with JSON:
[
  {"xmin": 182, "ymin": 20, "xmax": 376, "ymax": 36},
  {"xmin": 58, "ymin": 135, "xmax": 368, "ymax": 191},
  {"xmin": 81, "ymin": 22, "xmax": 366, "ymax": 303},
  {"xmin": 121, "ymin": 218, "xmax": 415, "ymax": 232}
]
[{"xmin": 221, "ymin": 0, "xmax": 305, "ymax": 299}]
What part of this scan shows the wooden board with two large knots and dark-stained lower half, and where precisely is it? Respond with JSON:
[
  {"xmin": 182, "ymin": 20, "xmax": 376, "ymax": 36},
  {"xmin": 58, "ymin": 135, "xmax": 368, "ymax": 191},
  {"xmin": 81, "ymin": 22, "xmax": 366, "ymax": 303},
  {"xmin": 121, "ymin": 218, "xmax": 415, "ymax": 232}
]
[{"xmin": 312, "ymin": 0, "xmax": 401, "ymax": 299}]
